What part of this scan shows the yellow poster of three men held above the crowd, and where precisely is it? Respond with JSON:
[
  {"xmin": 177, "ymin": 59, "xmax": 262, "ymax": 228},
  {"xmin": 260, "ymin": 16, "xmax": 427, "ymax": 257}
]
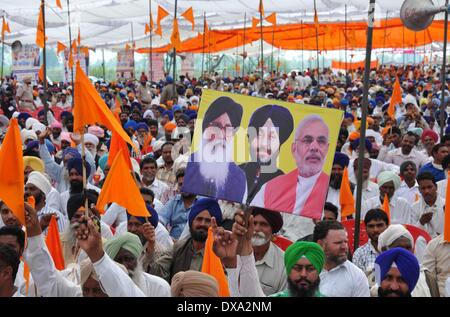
[{"xmin": 181, "ymin": 90, "xmax": 343, "ymax": 219}]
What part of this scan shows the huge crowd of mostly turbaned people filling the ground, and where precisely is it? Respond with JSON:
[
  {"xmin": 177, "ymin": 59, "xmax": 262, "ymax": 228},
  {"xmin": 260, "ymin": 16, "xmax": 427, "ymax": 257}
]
[{"xmin": 0, "ymin": 65, "xmax": 450, "ymax": 297}]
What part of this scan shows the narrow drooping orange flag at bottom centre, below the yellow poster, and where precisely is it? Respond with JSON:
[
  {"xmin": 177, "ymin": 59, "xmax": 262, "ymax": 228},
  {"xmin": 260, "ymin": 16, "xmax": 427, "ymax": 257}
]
[{"xmin": 202, "ymin": 227, "xmax": 230, "ymax": 297}]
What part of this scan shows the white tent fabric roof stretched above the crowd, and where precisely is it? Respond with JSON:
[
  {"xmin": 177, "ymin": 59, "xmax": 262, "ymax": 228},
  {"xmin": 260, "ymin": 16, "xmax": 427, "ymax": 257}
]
[{"xmin": 0, "ymin": 0, "xmax": 445, "ymax": 49}]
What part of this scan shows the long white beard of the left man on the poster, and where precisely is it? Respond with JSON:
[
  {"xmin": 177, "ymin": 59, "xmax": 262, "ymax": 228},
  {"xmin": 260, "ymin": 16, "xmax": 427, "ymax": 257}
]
[{"xmin": 198, "ymin": 139, "xmax": 233, "ymax": 188}]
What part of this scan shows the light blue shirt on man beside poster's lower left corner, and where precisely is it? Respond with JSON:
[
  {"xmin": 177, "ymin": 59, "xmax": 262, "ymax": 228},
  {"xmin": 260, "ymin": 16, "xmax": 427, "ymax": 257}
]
[{"xmin": 158, "ymin": 194, "xmax": 197, "ymax": 239}]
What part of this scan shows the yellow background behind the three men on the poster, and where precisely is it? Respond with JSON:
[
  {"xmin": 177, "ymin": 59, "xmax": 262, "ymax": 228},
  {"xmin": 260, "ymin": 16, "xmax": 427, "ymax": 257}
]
[{"xmin": 191, "ymin": 89, "xmax": 344, "ymax": 175}]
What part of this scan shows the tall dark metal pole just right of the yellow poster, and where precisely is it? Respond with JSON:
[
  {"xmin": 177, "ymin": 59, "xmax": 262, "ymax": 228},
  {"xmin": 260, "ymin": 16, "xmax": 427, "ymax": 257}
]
[{"xmin": 354, "ymin": 0, "xmax": 375, "ymax": 250}]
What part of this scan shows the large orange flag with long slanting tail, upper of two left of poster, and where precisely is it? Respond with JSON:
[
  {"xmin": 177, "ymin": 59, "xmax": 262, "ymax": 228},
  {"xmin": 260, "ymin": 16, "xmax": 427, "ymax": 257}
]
[{"xmin": 72, "ymin": 63, "xmax": 139, "ymax": 152}]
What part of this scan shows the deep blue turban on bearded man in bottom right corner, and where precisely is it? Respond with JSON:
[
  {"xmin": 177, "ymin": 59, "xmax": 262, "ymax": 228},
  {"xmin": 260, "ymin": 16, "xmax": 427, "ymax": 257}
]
[{"xmin": 375, "ymin": 248, "xmax": 420, "ymax": 293}]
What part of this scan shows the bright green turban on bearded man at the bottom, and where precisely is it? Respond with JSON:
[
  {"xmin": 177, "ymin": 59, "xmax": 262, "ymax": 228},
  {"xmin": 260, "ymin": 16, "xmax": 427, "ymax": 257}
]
[{"xmin": 284, "ymin": 241, "xmax": 325, "ymax": 275}]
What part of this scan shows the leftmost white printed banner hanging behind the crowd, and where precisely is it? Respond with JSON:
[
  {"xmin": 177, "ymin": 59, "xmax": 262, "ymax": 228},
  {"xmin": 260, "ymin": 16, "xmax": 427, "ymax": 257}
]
[{"xmin": 11, "ymin": 44, "xmax": 41, "ymax": 82}]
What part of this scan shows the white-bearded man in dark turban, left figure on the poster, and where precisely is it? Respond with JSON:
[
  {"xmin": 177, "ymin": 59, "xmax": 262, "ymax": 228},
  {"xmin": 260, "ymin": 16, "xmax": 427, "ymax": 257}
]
[{"xmin": 182, "ymin": 97, "xmax": 247, "ymax": 202}]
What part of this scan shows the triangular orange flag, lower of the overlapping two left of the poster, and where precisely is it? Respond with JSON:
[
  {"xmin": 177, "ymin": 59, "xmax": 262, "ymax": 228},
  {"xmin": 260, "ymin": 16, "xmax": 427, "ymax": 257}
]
[{"xmin": 97, "ymin": 151, "xmax": 150, "ymax": 217}]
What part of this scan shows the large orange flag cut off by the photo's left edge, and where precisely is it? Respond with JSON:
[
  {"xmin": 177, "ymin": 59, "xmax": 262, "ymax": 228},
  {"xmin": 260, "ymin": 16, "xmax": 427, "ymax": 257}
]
[{"xmin": 0, "ymin": 119, "xmax": 25, "ymax": 225}]
